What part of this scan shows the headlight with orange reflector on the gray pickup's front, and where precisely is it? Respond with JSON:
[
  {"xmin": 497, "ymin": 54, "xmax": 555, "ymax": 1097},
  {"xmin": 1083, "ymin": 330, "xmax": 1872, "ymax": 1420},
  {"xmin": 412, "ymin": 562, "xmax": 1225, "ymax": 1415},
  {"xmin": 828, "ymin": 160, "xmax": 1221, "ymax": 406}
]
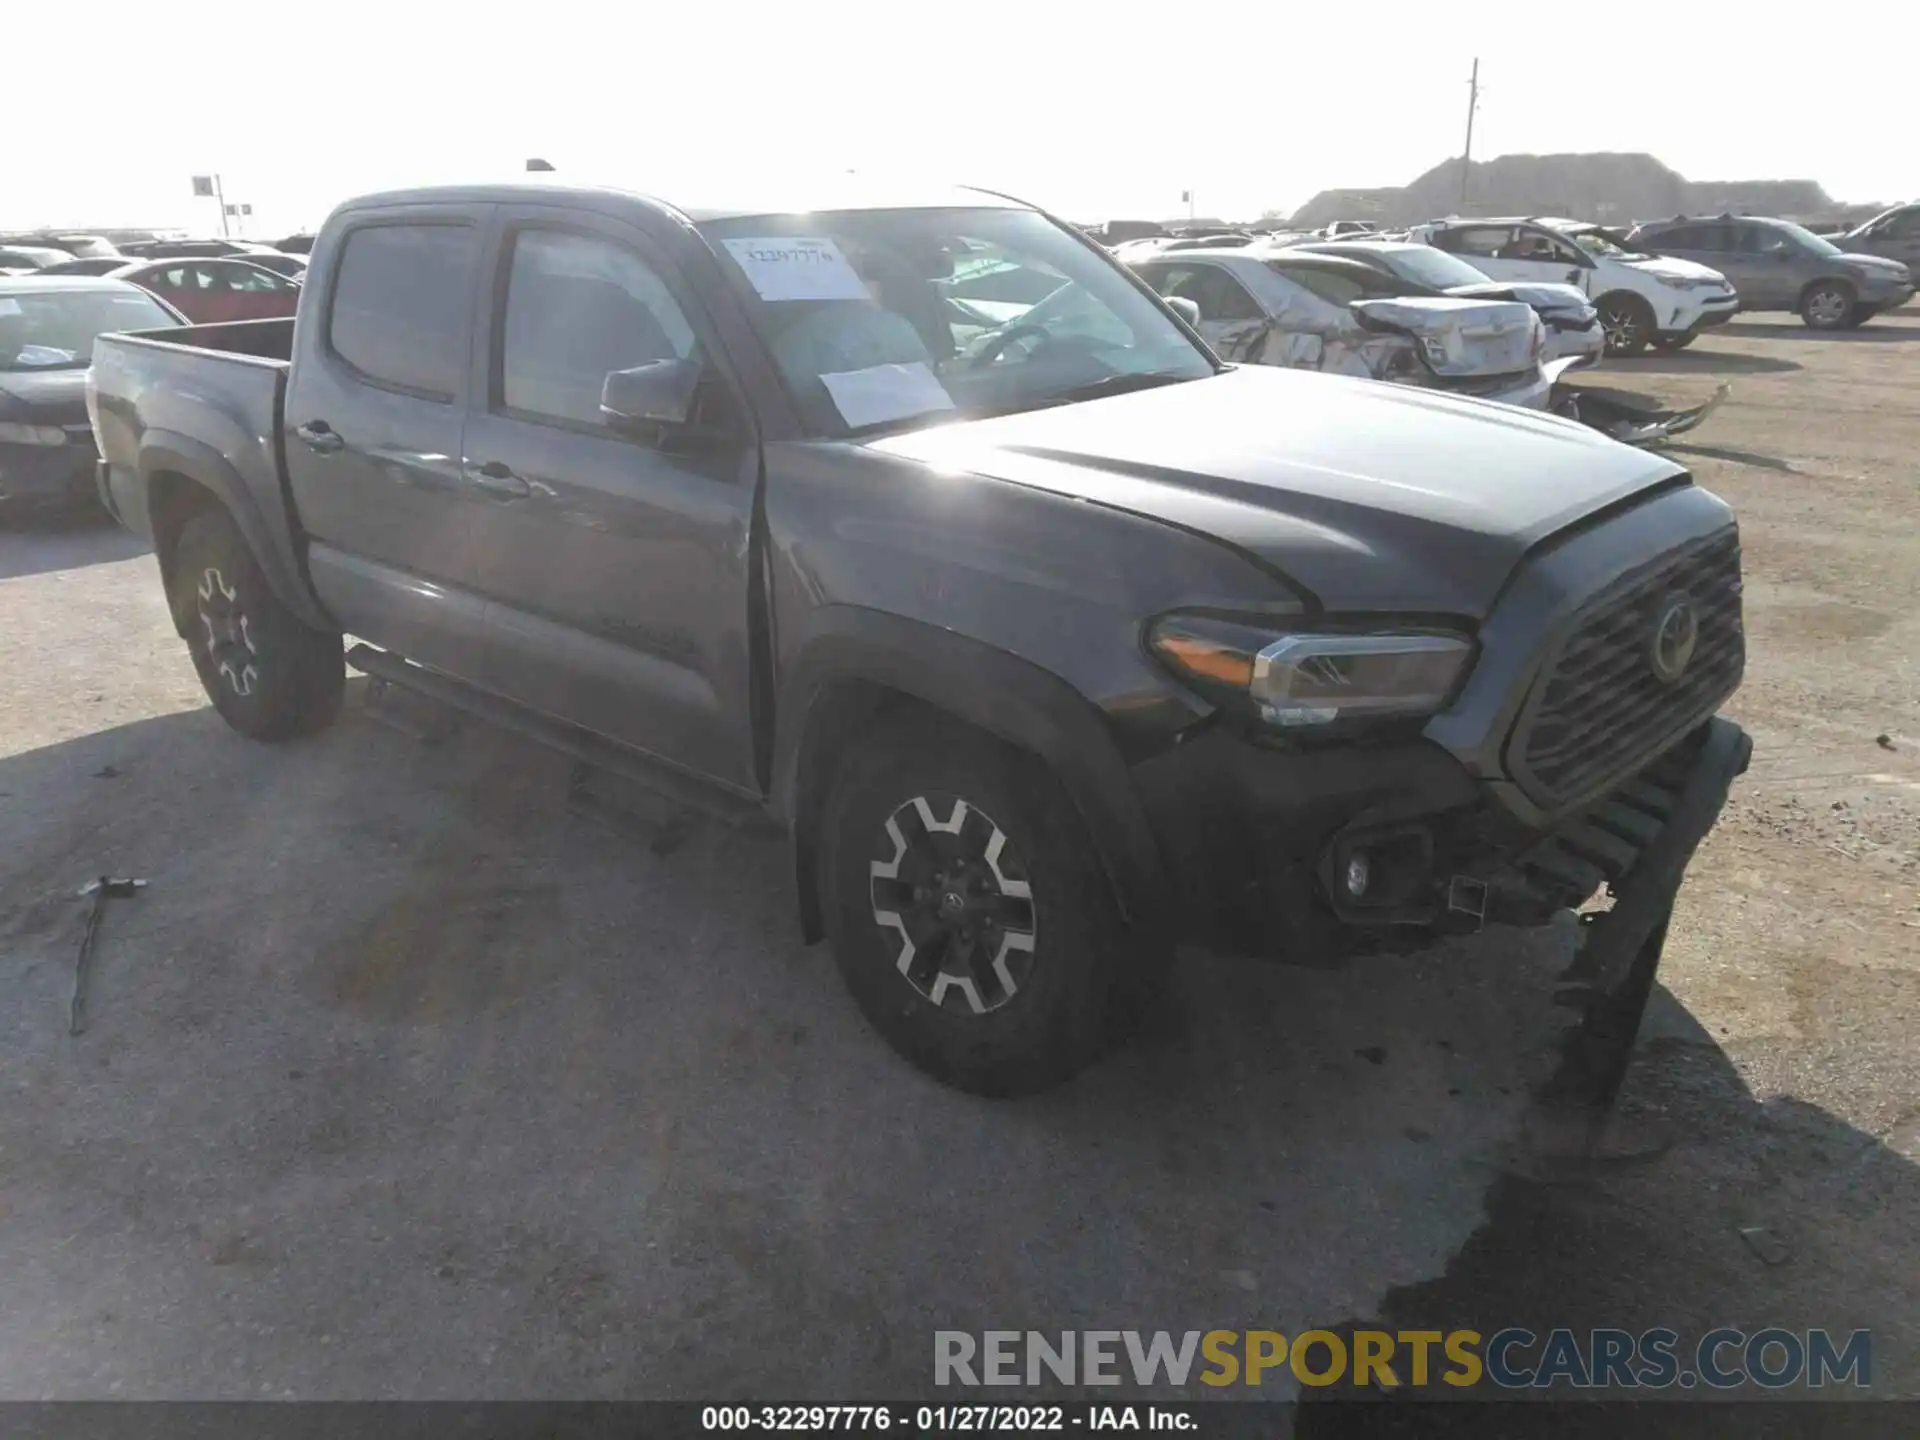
[{"xmin": 1146, "ymin": 614, "xmax": 1473, "ymax": 730}]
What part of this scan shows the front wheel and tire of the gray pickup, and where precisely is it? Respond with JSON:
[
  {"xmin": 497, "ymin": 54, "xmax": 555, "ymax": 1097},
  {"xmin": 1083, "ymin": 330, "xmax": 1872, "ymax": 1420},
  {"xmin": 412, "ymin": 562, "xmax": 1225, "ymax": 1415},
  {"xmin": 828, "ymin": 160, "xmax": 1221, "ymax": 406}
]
[{"xmin": 822, "ymin": 718, "xmax": 1125, "ymax": 1096}]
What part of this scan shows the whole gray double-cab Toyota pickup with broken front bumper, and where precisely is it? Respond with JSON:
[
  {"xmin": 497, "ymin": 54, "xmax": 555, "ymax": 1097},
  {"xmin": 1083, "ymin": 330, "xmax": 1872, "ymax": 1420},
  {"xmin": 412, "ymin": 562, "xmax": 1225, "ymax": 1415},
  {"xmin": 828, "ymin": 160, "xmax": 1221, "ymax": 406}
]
[{"xmin": 88, "ymin": 177, "xmax": 1749, "ymax": 1094}]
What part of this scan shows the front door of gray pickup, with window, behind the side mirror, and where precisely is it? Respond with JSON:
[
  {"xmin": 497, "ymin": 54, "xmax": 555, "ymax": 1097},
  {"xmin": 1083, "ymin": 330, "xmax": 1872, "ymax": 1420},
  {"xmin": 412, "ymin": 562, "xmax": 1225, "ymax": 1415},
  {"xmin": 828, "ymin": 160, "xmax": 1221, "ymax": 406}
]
[{"xmin": 461, "ymin": 205, "xmax": 758, "ymax": 793}]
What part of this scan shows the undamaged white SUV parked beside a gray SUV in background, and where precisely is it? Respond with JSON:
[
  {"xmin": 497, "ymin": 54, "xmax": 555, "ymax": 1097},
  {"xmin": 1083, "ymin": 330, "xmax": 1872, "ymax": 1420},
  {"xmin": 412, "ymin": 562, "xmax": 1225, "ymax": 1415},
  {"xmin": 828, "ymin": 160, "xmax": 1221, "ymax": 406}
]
[{"xmin": 1407, "ymin": 217, "xmax": 1740, "ymax": 355}]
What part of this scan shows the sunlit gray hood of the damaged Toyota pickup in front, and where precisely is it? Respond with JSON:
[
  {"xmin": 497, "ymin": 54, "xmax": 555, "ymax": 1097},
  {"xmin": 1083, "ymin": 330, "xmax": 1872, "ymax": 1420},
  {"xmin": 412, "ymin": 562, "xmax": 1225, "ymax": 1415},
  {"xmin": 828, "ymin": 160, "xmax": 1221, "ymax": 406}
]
[{"xmin": 866, "ymin": 365, "xmax": 1684, "ymax": 618}]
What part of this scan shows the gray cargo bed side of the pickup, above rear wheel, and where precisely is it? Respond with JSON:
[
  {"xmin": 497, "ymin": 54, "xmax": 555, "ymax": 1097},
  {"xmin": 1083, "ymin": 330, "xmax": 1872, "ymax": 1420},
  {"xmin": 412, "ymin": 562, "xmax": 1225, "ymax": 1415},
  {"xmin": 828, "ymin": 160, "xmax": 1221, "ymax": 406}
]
[{"xmin": 88, "ymin": 319, "xmax": 303, "ymax": 622}]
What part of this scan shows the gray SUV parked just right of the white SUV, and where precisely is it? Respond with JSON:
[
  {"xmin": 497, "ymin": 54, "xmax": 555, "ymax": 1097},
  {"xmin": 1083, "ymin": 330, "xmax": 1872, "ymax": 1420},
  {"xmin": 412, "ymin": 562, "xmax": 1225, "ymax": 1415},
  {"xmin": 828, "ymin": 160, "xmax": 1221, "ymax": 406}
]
[{"xmin": 1628, "ymin": 215, "xmax": 1914, "ymax": 330}]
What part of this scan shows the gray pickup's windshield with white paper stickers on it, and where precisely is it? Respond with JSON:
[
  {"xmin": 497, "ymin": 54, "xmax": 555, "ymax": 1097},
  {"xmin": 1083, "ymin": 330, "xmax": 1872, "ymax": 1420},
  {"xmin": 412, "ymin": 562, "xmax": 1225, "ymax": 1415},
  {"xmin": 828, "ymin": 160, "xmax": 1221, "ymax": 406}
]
[{"xmin": 701, "ymin": 209, "xmax": 1213, "ymax": 438}]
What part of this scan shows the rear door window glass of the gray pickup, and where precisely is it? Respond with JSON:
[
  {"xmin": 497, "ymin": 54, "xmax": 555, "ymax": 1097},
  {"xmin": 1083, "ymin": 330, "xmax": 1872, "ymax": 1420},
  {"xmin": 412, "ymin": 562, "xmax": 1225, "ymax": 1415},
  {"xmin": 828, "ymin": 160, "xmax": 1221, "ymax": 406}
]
[{"xmin": 326, "ymin": 225, "xmax": 480, "ymax": 403}]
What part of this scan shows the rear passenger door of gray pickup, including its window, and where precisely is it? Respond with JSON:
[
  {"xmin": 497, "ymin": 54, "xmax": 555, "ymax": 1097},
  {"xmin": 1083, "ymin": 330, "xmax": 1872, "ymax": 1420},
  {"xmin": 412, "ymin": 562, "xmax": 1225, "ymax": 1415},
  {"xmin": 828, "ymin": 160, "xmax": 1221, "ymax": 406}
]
[{"xmin": 284, "ymin": 205, "xmax": 492, "ymax": 678}]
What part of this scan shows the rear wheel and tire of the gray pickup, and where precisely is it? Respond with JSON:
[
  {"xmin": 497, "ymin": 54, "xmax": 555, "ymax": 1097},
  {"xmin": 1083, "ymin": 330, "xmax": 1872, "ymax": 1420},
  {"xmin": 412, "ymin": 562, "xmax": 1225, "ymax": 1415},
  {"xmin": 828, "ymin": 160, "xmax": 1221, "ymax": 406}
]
[{"xmin": 167, "ymin": 511, "xmax": 346, "ymax": 741}]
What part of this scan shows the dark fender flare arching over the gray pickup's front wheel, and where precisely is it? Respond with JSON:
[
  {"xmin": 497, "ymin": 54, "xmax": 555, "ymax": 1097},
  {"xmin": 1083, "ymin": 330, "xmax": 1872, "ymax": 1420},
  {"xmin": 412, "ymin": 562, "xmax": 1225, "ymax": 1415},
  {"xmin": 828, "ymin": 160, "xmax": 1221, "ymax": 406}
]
[{"xmin": 774, "ymin": 605, "xmax": 1167, "ymax": 939}]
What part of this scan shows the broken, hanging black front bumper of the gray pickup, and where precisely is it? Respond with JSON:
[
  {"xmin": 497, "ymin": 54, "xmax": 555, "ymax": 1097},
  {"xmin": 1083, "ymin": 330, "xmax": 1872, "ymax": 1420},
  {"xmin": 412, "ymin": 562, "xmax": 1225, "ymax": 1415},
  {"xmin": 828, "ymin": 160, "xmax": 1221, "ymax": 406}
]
[{"xmin": 1135, "ymin": 718, "xmax": 1753, "ymax": 971}]
